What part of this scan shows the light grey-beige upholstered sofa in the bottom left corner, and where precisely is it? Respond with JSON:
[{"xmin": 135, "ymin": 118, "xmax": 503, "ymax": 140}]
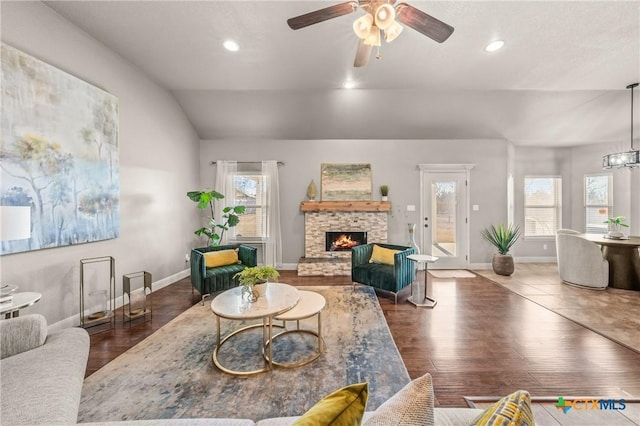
[{"xmin": 0, "ymin": 315, "xmax": 89, "ymax": 426}]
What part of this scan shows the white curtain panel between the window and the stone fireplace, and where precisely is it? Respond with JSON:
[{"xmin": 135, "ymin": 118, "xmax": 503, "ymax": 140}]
[{"xmin": 262, "ymin": 161, "xmax": 282, "ymax": 268}]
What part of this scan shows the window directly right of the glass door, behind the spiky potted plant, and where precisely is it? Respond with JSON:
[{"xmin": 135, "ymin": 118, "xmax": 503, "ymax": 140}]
[{"xmin": 524, "ymin": 176, "xmax": 562, "ymax": 237}]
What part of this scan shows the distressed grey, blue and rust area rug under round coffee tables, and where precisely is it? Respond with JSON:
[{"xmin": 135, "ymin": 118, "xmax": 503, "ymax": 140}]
[{"xmin": 78, "ymin": 286, "xmax": 410, "ymax": 422}]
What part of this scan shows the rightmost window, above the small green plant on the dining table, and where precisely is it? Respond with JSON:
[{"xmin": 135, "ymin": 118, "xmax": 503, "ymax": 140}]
[{"xmin": 584, "ymin": 174, "xmax": 613, "ymax": 234}]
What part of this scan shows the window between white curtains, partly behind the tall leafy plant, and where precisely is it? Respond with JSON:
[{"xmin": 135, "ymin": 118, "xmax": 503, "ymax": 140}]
[{"xmin": 232, "ymin": 172, "xmax": 269, "ymax": 241}]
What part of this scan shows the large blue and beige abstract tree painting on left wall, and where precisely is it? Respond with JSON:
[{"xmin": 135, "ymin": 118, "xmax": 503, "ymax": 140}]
[{"xmin": 0, "ymin": 43, "xmax": 120, "ymax": 255}]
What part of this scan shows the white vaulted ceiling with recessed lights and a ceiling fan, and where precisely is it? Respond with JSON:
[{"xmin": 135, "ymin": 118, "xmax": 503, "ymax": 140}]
[{"xmin": 45, "ymin": 0, "xmax": 640, "ymax": 146}]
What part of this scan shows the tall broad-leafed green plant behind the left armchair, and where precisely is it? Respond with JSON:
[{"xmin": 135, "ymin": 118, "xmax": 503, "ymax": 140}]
[{"xmin": 187, "ymin": 190, "xmax": 245, "ymax": 246}]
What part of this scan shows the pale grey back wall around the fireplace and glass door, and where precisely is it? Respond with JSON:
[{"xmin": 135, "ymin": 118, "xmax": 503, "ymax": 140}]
[{"xmin": 200, "ymin": 140, "xmax": 508, "ymax": 264}]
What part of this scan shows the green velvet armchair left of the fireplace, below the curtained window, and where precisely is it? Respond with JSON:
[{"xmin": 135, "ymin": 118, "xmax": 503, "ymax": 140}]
[{"xmin": 191, "ymin": 244, "xmax": 258, "ymax": 302}]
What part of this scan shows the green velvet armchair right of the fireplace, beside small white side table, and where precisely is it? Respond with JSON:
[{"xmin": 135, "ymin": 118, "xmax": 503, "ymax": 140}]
[{"xmin": 351, "ymin": 244, "xmax": 416, "ymax": 303}]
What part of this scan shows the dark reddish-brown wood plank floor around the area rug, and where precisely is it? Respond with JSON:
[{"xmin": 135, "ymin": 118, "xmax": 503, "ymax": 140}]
[{"xmin": 87, "ymin": 271, "xmax": 640, "ymax": 406}]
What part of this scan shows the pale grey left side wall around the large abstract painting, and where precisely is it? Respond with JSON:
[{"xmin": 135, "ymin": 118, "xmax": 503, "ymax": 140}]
[{"xmin": 0, "ymin": 2, "xmax": 199, "ymax": 324}]
